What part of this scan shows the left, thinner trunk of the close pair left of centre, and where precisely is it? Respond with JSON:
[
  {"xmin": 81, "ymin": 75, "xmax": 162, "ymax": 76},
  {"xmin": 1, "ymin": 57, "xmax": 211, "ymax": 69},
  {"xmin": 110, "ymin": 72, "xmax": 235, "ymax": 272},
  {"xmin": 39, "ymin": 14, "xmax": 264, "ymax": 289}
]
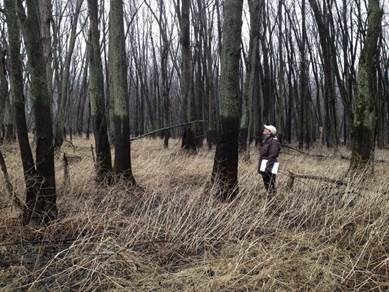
[{"xmin": 88, "ymin": 0, "xmax": 112, "ymax": 181}]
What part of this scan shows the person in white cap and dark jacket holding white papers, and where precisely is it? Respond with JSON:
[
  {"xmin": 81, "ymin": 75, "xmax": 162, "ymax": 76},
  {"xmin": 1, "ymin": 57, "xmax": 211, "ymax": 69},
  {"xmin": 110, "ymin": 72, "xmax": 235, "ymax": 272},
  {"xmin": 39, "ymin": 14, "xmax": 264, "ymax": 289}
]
[{"xmin": 258, "ymin": 125, "xmax": 281, "ymax": 196}]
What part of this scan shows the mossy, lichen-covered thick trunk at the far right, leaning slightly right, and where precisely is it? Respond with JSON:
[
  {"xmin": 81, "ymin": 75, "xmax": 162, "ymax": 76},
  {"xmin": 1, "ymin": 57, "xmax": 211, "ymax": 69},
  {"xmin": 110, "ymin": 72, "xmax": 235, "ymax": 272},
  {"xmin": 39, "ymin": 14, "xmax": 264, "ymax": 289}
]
[{"xmin": 350, "ymin": 0, "xmax": 383, "ymax": 170}]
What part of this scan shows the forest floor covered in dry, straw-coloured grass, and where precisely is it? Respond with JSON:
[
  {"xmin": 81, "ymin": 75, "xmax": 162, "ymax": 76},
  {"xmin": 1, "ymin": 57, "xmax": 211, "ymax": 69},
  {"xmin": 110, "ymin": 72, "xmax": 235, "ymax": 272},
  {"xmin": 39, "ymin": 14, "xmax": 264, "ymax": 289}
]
[{"xmin": 0, "ymin": 139, "xmax": 389, "ymax": 291}]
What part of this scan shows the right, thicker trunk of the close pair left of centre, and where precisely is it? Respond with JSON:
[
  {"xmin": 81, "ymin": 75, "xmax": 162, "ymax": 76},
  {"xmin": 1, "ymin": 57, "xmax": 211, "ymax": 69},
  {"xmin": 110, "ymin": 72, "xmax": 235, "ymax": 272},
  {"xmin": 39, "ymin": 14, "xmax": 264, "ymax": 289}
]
[{"xmin": 109, "ymin": 0, "xmax": 135, "ymax": 184}]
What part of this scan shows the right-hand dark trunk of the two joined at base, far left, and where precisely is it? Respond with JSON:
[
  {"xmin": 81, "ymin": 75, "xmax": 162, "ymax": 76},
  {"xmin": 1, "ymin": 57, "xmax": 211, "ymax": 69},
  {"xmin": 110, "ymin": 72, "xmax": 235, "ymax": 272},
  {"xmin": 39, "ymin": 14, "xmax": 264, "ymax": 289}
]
[{"xmin": 18, "ymin": 0, "xmax": 58, "ymax": 224}]
